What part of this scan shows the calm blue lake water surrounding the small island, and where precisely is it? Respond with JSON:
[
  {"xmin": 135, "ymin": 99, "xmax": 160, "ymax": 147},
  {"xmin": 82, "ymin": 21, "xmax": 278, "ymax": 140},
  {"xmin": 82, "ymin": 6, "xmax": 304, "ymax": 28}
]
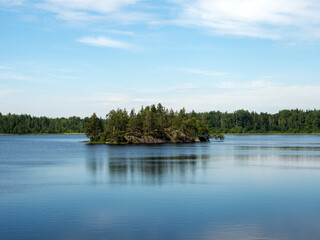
[{"xmin": 0, "ymin": 135, "xmax": 320, "ymax": 240}]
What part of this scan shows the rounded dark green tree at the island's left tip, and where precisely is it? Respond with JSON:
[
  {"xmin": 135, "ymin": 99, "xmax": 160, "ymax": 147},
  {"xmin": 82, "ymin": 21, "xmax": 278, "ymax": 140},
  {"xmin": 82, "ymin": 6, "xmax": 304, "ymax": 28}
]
[{"xmin": 84, "ymin": 113, "xmax": 104, "ymax": 142}]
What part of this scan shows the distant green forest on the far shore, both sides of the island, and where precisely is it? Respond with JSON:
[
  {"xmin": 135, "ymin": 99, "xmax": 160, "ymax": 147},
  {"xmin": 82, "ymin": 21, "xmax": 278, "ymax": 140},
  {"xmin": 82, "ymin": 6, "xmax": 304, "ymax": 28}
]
[{"xmin": 0, "ymin": 109, "xmax": 320, "ymax": 134}]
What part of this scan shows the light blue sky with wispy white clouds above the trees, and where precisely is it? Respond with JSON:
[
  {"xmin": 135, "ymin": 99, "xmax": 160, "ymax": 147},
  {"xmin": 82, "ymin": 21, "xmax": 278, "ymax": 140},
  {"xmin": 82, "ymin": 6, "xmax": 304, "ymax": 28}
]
[{"xmin": 0, "ymin": 0, "xmax": 320, "ymax": 117}]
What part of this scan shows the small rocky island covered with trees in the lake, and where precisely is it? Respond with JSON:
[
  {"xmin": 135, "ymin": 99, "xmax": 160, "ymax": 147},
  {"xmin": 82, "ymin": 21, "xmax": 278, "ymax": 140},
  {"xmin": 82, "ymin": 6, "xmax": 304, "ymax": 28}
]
[{"xmin": 85, "ymin": 103, "xmax": 224, "ymax": 144}]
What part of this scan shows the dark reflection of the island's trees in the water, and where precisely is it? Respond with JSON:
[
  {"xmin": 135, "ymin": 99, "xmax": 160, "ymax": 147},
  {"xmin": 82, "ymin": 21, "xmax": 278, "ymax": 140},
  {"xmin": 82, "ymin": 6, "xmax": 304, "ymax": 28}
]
[{"xmin": 87, "ymin": 146, "xmax": 208, "ymax": 184}]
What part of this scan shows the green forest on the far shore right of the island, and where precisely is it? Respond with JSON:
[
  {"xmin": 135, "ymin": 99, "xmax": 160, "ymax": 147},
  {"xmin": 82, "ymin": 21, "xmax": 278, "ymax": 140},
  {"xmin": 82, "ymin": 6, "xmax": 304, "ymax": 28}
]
[{"xmin": 205, "ymin": 109, "xmax": 320, "ymax": 133}]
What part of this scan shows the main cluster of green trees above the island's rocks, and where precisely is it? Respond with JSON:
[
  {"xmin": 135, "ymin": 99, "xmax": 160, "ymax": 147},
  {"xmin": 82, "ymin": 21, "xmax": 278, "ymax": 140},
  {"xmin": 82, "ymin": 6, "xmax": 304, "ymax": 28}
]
[{"xmin": 101, "ymin": 103, "xmax": 209, "ymax": 143}]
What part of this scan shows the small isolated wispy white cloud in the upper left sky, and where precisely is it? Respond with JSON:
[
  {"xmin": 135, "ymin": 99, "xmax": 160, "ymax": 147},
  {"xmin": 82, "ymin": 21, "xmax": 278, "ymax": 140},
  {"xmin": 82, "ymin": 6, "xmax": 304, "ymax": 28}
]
[{"xmin": 77, "ymin": 37, "xmax": 132, "ymax": 49}]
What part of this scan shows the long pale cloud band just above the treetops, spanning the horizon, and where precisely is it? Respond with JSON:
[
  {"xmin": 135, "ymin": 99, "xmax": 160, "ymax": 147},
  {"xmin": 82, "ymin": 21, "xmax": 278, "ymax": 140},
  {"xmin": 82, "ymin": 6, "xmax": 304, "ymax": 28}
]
[{"xmin": 0, "ymin": 81, "xmax": 320, "ymax": 117}]
